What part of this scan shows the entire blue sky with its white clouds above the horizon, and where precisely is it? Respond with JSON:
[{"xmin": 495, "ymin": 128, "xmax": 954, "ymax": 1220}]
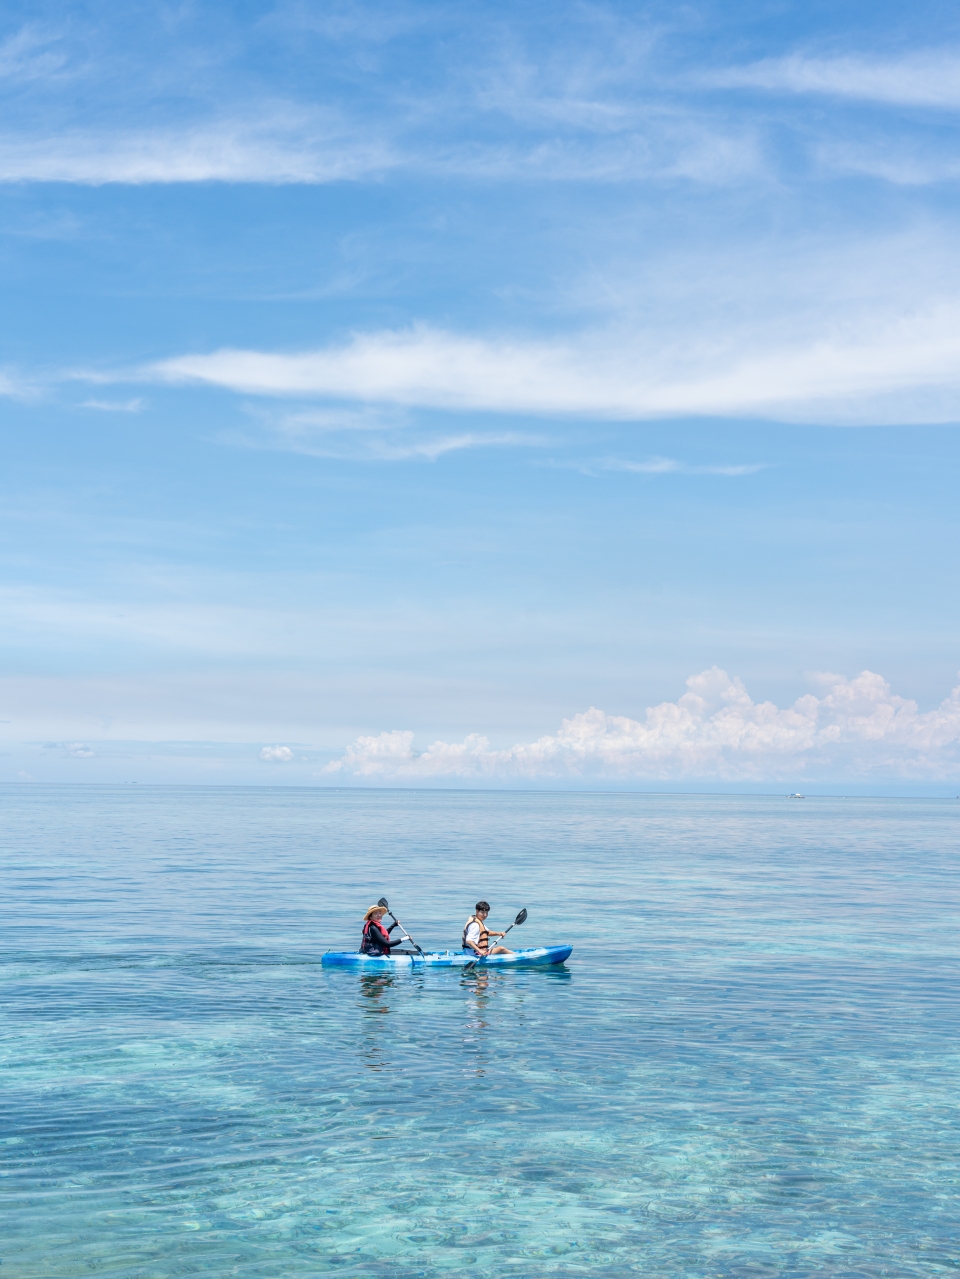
[{"xmin": 0, "ymin": 3, "xmax": 960, "ymax": 793}]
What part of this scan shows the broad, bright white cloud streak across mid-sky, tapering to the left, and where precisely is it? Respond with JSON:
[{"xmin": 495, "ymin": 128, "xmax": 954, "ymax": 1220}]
[{"xmin": 142, "ymin": 302, "xmax": 960, "ymax": 422}]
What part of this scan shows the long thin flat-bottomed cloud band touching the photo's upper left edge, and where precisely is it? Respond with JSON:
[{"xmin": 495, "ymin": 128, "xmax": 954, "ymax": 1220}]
[{"xmin": 0, "ymin": 113, "xmax": 763, "ymax": 185}]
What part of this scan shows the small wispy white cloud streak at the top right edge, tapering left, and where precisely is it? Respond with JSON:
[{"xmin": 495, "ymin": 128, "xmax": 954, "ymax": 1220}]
[{"xmin": 708, "ymin": 50, "xmax": 960, "ymax": 110}]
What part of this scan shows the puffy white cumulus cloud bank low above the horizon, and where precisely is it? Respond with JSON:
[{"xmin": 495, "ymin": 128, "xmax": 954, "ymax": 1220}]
[{"xmin": 323, "ymin": 666, "xmax": 960, "ymax": 781}]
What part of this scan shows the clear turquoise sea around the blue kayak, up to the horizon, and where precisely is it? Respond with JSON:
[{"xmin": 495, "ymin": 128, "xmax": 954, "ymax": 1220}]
[{"xmin": 0, "ymin": 787, "xmax": 960, "ymax": 1279}]
